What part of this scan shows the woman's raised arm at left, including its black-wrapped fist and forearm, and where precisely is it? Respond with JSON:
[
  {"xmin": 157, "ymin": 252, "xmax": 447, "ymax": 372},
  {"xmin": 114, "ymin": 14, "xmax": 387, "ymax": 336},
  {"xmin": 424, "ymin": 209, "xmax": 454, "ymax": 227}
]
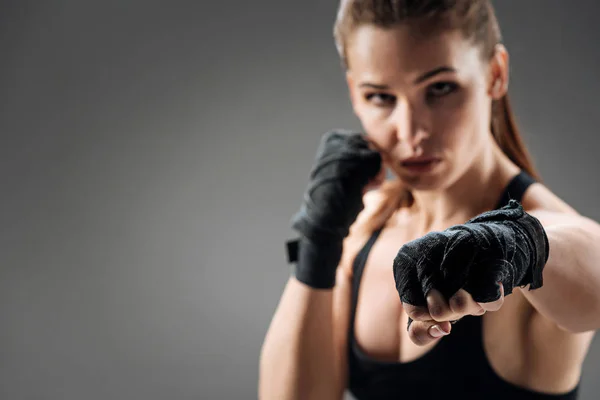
[{"xmin": 258, "ymin": 131, "xmax": 385, "ymax": 400}]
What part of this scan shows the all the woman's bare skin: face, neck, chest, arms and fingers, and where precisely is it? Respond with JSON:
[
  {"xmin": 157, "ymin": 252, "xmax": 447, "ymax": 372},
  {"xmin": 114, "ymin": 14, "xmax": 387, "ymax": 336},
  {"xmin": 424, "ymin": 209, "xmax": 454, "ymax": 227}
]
[{"xmin": 258, "ymin": 25, "xmax": 600, "ymax": 400}]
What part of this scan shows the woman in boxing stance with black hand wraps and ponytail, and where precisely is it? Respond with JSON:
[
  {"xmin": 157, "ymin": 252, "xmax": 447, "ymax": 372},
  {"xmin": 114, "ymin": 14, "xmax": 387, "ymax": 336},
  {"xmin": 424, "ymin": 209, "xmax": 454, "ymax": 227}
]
[{"xmin": 259, "ymin": 0, "xmax": 600, "ymax": 399}]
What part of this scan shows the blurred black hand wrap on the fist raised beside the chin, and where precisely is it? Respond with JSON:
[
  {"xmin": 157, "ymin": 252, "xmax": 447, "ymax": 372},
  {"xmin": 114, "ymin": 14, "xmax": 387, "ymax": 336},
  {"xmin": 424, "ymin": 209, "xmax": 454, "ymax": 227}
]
[{"xmin": 292, "ymin": 131, "xmax": 381, "ymax": 288}]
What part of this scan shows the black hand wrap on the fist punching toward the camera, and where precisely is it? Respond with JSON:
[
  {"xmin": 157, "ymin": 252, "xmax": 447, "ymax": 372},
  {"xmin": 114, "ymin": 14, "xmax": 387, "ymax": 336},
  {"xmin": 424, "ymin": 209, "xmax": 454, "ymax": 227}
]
[{"xmin": 394, "ymin": 200, "xmax": 549, "ymax": 306}]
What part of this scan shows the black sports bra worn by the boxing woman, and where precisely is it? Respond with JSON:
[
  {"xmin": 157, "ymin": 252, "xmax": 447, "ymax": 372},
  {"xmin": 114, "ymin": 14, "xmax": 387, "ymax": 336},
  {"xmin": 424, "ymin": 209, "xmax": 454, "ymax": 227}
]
[{"xmin": 348, "ymin": 172, "xmax": 579, "ymax": 400}]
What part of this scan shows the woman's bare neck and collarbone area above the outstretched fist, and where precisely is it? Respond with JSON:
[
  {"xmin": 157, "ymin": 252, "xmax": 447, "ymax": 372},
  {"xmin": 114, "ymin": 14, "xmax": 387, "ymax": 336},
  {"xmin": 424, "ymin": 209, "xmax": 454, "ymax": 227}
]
[{"xmin": 411, "ymin": 143, "xmax": 519, "ymax": 232}]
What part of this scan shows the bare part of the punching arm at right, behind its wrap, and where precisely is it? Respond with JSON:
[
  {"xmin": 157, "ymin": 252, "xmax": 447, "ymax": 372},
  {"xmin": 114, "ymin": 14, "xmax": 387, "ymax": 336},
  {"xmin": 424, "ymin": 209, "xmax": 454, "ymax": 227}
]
[{"xmin": 522, "ymin": 210, "xmax": 600, "ymax": 333}]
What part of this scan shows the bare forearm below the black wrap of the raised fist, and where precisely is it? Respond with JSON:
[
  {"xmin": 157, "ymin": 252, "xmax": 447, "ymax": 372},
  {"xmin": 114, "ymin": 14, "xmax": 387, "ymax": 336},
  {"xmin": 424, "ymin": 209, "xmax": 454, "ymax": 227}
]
[{"xmin": 258, "ymin": 267, "xmax": 351, "ymax": 400}]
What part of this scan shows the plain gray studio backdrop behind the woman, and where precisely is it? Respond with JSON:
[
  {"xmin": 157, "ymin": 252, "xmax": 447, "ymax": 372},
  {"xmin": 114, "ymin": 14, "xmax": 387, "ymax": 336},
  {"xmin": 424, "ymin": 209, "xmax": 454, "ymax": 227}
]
[{"xmin": 0, "ymin": 0, "xmax": 600, "ymax": 400}]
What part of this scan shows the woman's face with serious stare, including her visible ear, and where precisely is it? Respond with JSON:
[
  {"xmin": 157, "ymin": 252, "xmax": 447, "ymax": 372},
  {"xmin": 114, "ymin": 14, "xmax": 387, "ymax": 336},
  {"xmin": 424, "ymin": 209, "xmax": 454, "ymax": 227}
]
[{"xmin": 346, "ymin": 25, "xmax": 507, "ymax": 190}]
